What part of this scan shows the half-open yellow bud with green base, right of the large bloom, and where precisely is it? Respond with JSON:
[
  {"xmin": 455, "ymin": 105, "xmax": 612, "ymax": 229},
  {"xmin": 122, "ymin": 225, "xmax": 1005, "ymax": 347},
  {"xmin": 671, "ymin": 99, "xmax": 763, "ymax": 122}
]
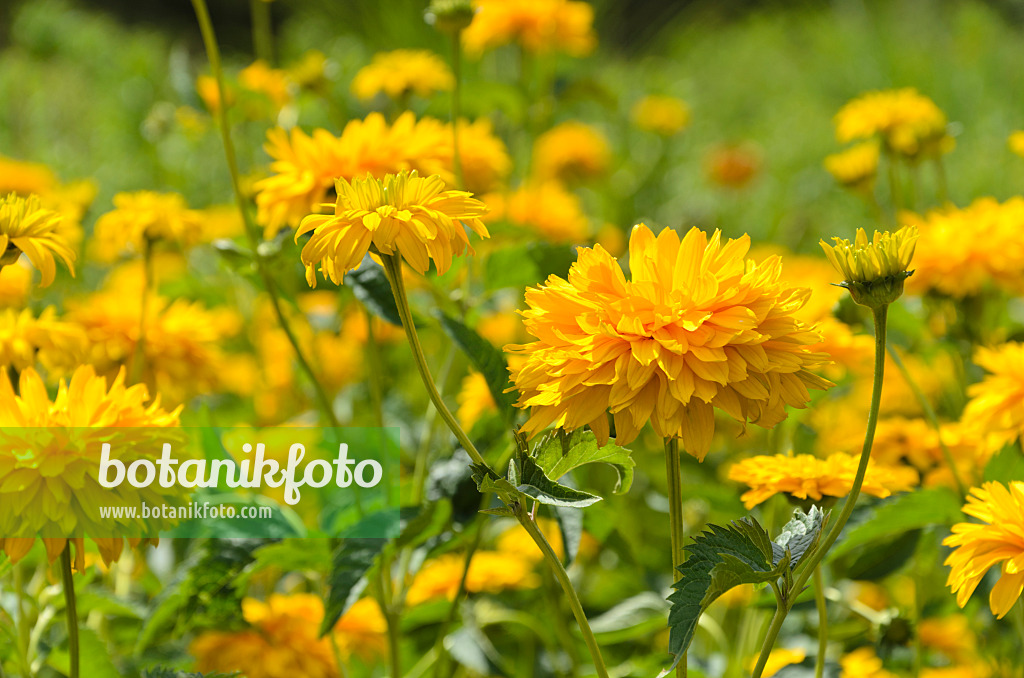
[{"xmin": 821, "ymin": 226, "xmax": 918, "ymax": 308}]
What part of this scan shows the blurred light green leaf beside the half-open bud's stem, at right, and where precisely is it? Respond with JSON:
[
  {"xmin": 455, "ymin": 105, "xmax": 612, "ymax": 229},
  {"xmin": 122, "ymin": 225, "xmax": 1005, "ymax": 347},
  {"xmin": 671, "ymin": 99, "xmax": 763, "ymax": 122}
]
[{"xmin": 828, "ymin": 488, "xmax": 963, "ymax": 561}]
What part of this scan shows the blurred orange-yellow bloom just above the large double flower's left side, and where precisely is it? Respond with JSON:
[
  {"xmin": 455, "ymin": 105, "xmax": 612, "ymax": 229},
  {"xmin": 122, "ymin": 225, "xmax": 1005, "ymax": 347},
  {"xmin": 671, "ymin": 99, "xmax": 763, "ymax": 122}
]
[{"xmin": 483, "ymin": 181, "xmax": 590, "ymax": 244}]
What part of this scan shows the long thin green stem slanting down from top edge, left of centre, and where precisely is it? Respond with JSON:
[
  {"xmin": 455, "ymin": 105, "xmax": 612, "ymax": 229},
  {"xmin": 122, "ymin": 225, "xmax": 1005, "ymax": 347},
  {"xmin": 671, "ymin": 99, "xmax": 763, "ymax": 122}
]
[{"xmin": 191, "ymin": 0, "xmax": 341, "ymax": 428}]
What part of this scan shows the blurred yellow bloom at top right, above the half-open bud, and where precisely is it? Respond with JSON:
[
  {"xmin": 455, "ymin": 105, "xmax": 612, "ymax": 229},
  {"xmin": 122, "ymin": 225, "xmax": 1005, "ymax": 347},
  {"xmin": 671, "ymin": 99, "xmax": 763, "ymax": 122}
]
[{"xmin": 835, "ymin": 87, "xmax": 952, "ymax": 158}]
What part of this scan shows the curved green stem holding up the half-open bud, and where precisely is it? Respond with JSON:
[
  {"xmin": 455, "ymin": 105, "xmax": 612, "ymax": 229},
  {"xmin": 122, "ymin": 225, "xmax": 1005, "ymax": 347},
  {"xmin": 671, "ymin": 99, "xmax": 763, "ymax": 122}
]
[{"xmin": 753, "ymin": 306, "xmax": 889, "ymax": 678}]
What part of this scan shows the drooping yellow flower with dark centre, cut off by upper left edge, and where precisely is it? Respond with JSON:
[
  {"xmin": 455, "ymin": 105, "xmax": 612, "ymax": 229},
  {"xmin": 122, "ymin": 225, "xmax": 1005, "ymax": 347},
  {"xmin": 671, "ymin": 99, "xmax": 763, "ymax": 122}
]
[{"xmin": 0, "ymin": 194, "xmax": 75, "ymax": 287}]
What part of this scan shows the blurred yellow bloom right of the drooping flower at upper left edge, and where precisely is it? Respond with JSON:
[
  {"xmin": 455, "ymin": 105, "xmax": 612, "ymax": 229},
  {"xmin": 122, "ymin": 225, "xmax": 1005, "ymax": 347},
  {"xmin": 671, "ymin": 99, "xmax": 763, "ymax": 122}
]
[{"xmin": 92, "ymin": 190, "xmax": 203, "ymax": 262}]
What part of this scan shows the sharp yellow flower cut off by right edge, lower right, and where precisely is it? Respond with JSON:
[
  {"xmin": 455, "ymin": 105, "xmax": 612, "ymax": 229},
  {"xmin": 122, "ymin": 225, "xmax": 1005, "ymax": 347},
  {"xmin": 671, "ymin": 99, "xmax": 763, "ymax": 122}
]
[{"xmin": 942, "ymin": 480, "xmax": 1024, "ymax": 619}]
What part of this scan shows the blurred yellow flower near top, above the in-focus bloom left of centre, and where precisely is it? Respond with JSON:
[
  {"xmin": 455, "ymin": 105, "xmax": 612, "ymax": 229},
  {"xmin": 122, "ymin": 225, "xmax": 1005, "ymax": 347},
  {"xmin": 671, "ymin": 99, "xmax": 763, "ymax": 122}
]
[{"xmin": 352, "ymin": 49, "xmax": 455, "ymax": 100}]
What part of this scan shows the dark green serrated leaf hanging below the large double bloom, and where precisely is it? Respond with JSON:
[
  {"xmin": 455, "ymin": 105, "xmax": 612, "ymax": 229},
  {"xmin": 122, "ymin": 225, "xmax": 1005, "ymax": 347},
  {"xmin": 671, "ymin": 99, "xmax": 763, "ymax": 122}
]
[{"xmin": 660, "ymin": 517, "xmax": 790, "ymax": 676}]
